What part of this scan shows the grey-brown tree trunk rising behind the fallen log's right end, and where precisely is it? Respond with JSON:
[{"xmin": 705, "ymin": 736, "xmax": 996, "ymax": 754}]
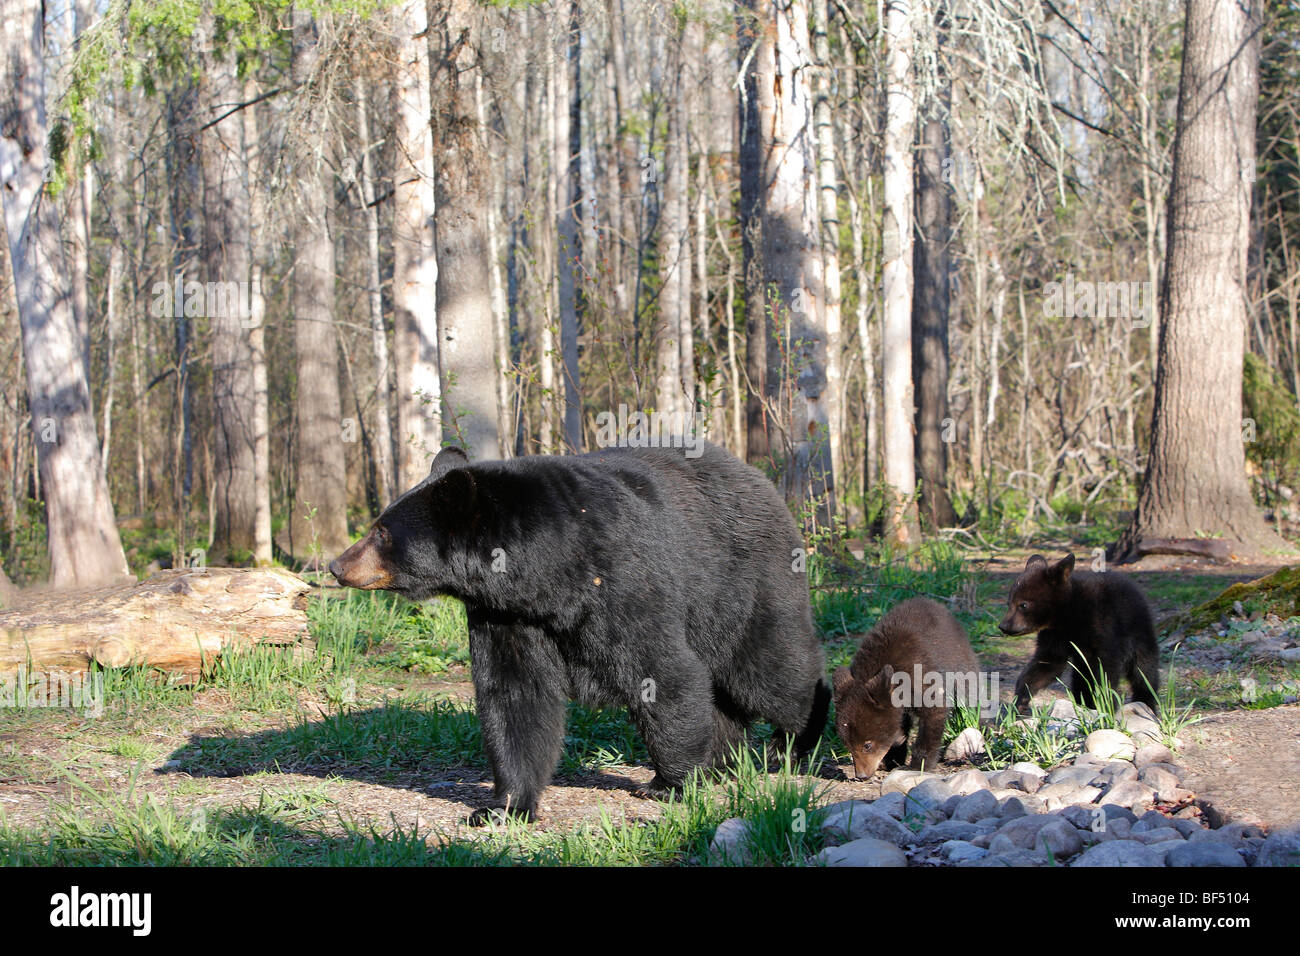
[{"xmin": 286, "ymin": 7, "xmax": 350, "ymax": 562}]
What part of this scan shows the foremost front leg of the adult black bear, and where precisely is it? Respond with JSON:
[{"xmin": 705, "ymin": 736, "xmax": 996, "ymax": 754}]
[{"xmin": 469, "ymin": 611, "xmax": 568, "ymax": 826}]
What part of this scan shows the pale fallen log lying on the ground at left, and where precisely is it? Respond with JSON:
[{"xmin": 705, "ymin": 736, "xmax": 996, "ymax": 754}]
[{"xmin": 0, "ymin": 567, "xmax": 311, "ymax": 680}]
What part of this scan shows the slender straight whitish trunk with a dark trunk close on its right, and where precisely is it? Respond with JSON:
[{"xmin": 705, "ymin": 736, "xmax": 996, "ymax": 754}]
[{"xmin": 880, "ymin": 0, "xmax": 918, "ymax": 548}]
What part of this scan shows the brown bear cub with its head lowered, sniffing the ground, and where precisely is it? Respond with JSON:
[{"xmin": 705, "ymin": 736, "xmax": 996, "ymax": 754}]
[{"xmin": 835, "ymin": 597, "xmax": 979, "ymax": 780}]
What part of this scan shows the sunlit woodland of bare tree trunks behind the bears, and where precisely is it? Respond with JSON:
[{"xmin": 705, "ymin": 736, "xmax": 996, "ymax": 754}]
[{"xmin": 0, "ymin": 0, "xmax": 1300, "ymax": 584}]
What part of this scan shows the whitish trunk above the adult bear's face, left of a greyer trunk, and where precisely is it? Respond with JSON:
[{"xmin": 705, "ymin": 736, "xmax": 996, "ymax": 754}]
[{"xmin": 393, "ymin": 0, "xmax": 442, "ymax": 489}]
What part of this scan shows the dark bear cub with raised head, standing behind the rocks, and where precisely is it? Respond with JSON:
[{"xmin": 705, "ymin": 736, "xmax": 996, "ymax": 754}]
[{"xmin": 998, "ymin": 554, "xmax": 1160, "ymax": 714}]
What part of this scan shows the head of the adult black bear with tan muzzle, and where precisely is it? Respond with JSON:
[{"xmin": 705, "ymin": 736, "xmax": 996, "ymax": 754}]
[{"xmin": 329, "ymin": 447, "xmax": 478, "ymax": 601}]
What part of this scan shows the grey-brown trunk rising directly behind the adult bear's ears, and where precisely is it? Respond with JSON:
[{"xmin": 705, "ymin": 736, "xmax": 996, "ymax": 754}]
[{"xmin": 429, "ymin": 0, "xmax": 501, "ymax": 462}]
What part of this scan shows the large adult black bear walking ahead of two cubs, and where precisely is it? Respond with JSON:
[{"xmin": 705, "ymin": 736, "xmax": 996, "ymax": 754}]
[{"xmin": 330, "ymin": 444, "xmax": 831, "ymax": 823}]
